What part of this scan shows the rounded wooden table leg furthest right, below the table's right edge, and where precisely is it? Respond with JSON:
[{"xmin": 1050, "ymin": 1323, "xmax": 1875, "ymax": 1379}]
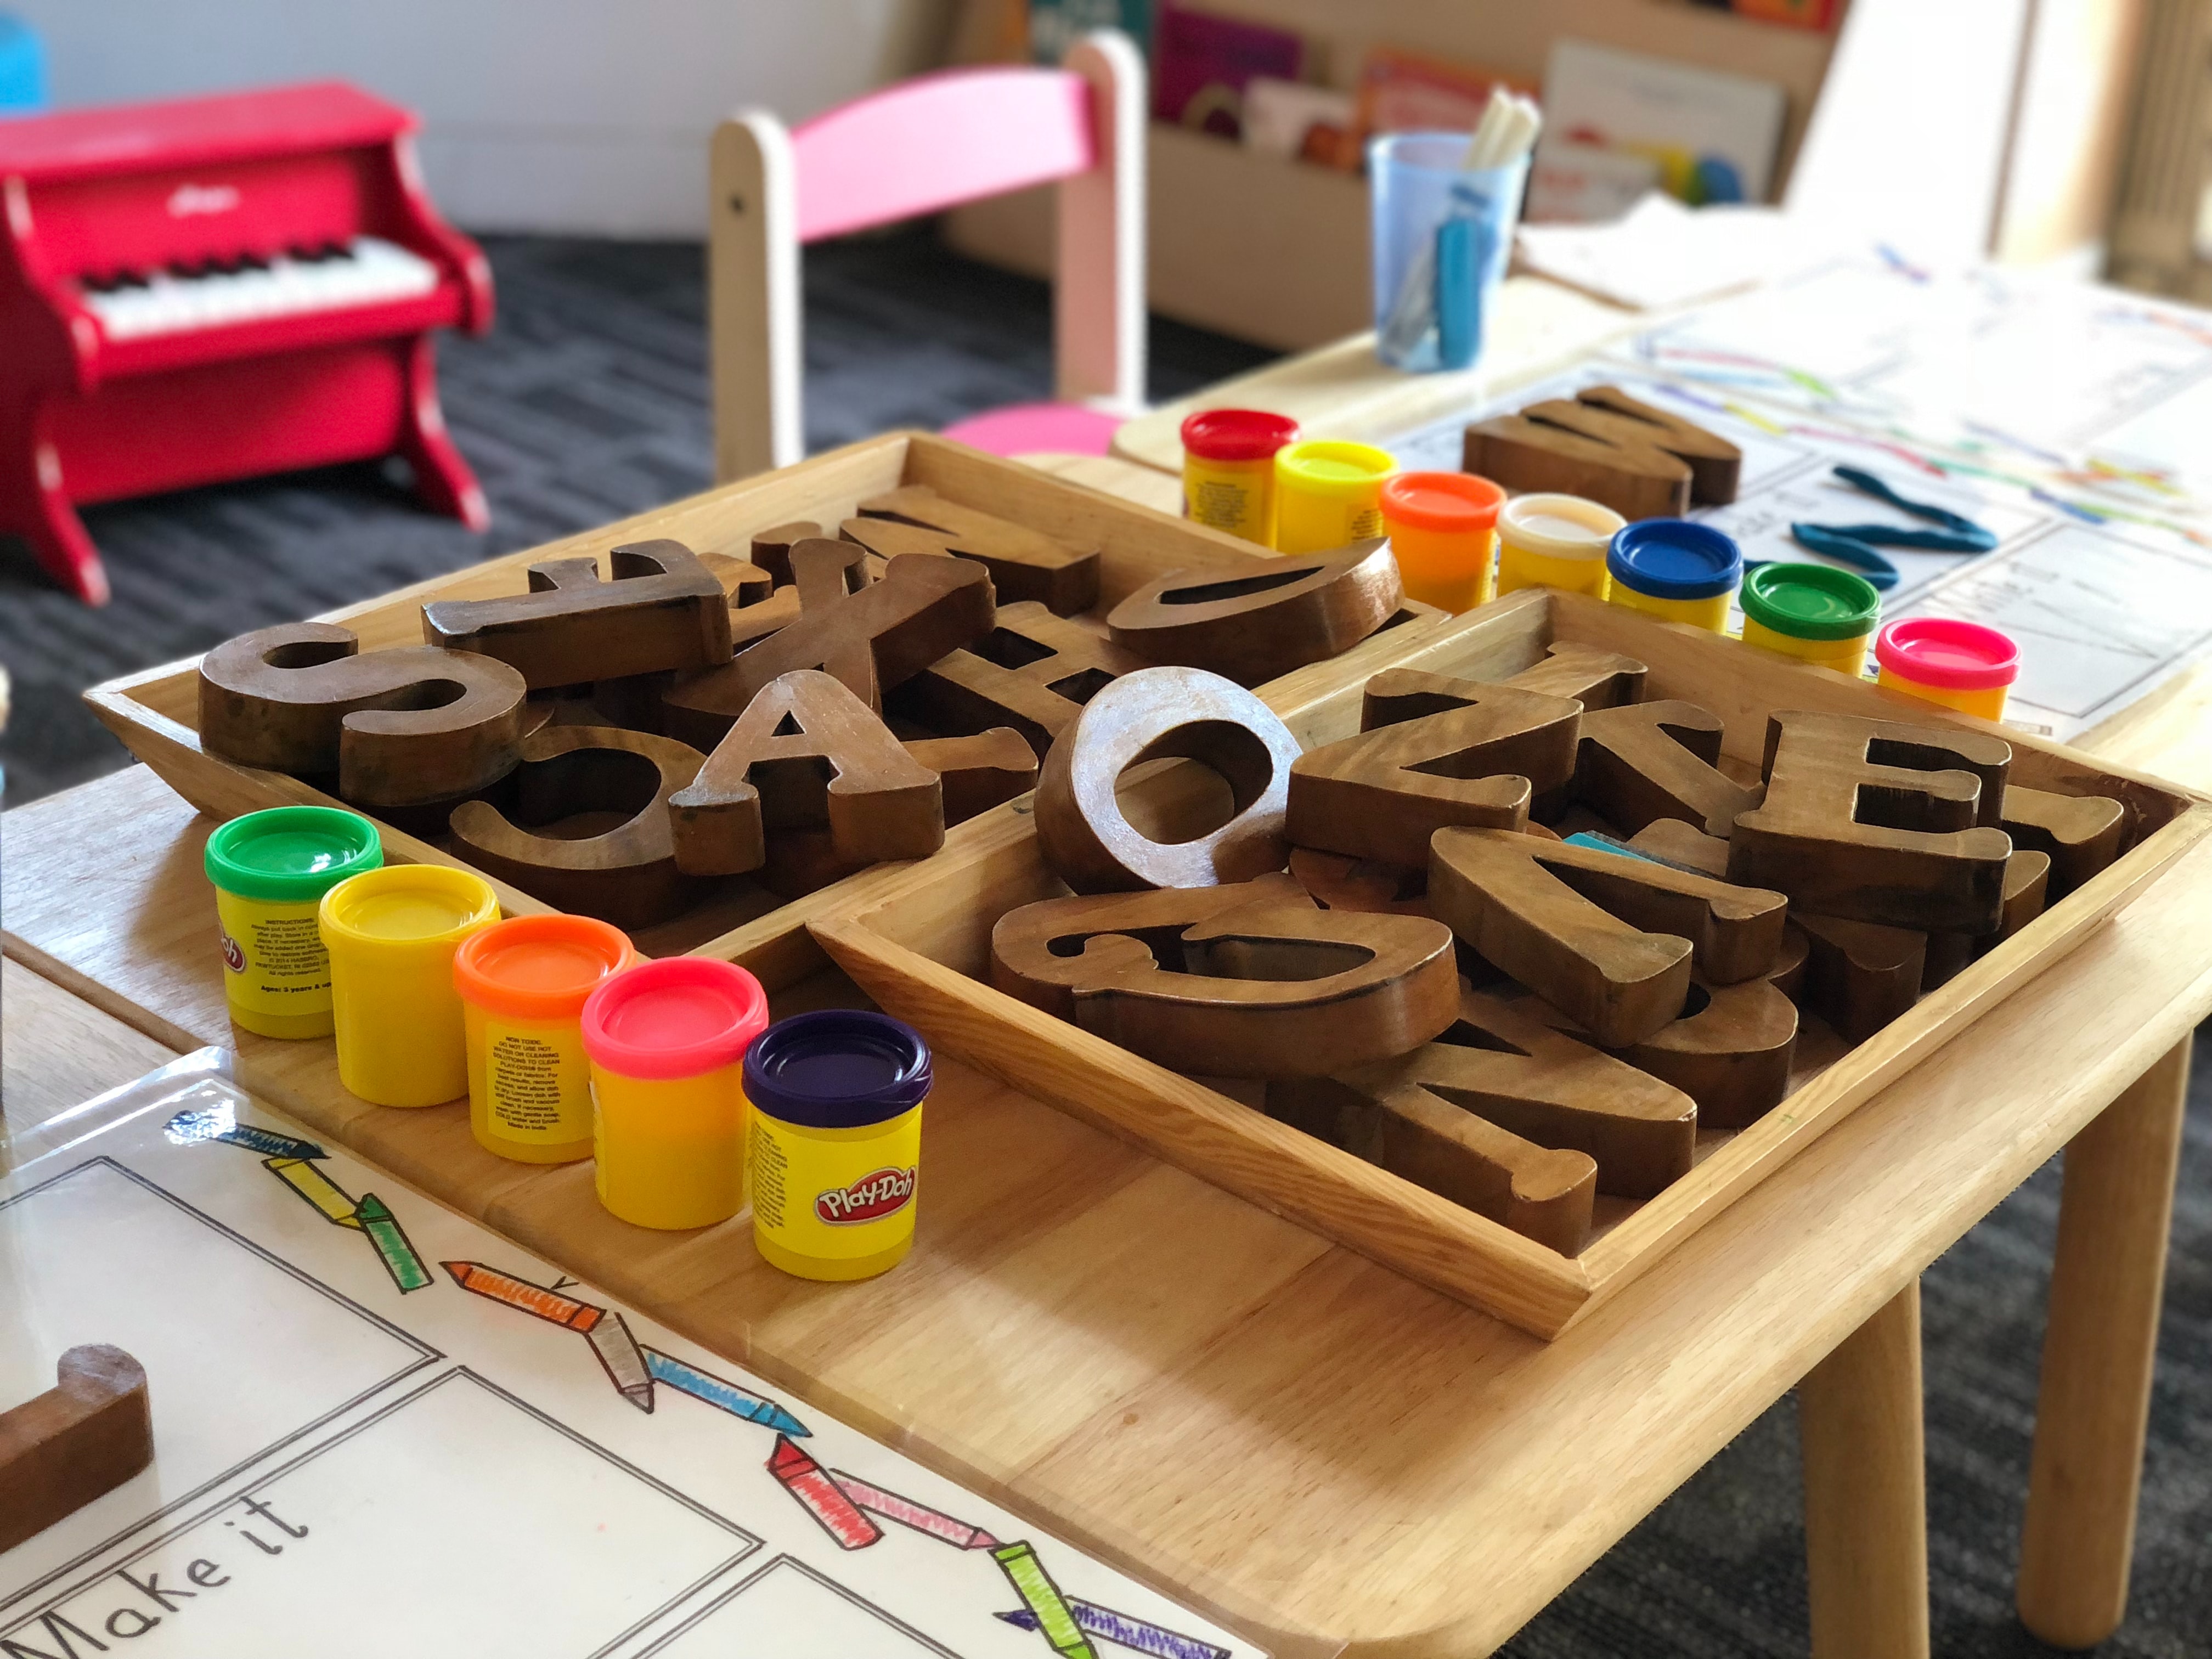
[{"xmin": 2019, "ymin": 1040, "xmax": 2190, "ymax": 1648}]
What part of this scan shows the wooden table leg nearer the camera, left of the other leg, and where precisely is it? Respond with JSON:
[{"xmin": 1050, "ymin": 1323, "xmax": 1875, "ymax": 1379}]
[{"xmin": 1798, "ymin": 1278, "xmax": 1929, "ymax": 1659}]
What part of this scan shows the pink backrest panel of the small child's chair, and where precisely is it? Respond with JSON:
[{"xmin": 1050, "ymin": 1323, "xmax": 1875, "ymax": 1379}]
[{"xmin": 792, "ymin": 66, "xmax": 1097, "ymax": 241}]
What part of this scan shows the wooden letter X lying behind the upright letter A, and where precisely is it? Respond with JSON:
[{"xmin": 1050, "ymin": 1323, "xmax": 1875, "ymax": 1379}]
[{"xmin": 664, "ymin": 542, "xmax": 993, "ymax": 748}]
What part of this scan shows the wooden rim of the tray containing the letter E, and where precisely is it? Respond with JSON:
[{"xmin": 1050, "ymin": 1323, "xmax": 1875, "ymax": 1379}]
[{"xmin": 810, "ymin": 593, "xmax": 2212, "ymax": 1338}]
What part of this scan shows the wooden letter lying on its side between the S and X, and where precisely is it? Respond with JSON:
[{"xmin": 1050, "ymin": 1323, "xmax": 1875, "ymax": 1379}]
[{"xmin": 422, "ymin": 542, "xmax": 747, "ymax": 690}]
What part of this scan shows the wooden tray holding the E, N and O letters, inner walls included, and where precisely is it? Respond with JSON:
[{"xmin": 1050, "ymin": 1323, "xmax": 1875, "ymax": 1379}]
[{"xmin": 810, "ymin": 591, "xmax": 2212, "ymax": 1338}]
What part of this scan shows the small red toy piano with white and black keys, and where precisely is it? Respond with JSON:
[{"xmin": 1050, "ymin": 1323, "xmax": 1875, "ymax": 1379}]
[{"xmin": 0, "ymin": 82, "xmax": 491, "ymax": 604}]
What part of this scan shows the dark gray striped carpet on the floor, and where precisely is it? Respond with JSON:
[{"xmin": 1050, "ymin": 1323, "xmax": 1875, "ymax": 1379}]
[{"xmin": 0, "ymin": 234, "xmax": 2212, "ymax": 1659}]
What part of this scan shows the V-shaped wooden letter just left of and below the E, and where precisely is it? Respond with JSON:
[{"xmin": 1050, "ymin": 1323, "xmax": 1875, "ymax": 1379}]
[{"xmin": 1429, "ymin": 830, "xmax": 1787, "ymax": 1048}]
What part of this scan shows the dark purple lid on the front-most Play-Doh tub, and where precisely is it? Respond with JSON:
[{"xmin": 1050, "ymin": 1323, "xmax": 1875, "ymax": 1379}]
[{"xmin": 746, "ymin": 1009, "xmax": 929, "ymax": 1128}]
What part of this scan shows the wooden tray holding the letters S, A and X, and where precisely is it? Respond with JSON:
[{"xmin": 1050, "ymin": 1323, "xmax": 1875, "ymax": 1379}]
[{"xmin": 84, "ymin": 433, "xmax": 1444, "ymax": 991}]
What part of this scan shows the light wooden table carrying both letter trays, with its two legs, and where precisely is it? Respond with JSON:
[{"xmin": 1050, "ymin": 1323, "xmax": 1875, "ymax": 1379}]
[{"xmin": 0, "ymin": 747, "xmax": 2212, "ymax": 1659}]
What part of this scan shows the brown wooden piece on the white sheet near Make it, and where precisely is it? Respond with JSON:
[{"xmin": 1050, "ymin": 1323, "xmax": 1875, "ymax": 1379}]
[{"xmin": 0, "ymin": 1331, "xmax": 153, "ymax": 1566}]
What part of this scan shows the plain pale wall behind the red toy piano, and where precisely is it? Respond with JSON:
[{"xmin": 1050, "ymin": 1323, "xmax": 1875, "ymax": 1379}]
[{"xmin": 4, "ymin": 0, "xmax": 949, "ymax": 236}]
